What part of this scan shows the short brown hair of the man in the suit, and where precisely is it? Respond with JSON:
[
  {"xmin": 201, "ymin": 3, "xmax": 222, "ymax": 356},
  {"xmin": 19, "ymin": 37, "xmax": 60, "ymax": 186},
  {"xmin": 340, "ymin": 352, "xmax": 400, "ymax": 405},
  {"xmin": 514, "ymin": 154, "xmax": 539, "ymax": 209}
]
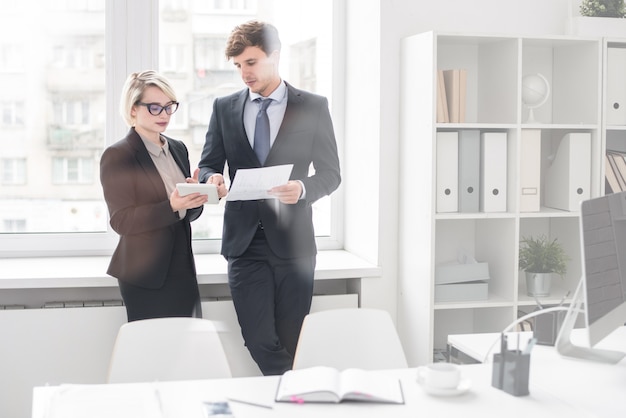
[{"xmin": 225, "ymin": 20, "xmax": 281, "ymax": 59}]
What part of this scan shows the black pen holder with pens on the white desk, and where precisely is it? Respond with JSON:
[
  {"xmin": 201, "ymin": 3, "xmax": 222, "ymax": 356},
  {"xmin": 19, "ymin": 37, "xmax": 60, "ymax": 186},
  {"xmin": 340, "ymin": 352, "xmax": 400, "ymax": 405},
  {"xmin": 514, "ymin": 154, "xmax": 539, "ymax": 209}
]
[{"xmin": 491, "ymin": 350, "xmax": 530, "ymax": 396}]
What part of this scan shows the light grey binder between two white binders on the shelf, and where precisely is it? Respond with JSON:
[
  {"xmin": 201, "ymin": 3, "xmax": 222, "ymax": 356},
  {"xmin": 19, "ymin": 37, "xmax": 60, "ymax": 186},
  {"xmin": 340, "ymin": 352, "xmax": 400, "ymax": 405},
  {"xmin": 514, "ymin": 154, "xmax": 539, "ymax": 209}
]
[{"xmin": 459, "ymin": 129, "xmax": 480, "ymax": 212}]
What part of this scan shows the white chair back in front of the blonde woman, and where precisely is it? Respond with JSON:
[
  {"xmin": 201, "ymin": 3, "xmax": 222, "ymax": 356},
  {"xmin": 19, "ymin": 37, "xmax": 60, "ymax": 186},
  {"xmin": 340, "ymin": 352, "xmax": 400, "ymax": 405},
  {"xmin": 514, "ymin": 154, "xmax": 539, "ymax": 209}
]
[{"xmin": 107, "ymin": 318, "xmax": 231, "ymax": 383}]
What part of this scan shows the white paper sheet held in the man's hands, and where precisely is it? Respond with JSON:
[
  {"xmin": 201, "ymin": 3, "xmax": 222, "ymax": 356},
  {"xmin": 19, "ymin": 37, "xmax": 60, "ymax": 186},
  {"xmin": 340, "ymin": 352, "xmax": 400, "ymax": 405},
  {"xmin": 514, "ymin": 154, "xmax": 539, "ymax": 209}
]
[{"xmin": 226, "ymin": 164, "xmax": 293, "ymax": 200}]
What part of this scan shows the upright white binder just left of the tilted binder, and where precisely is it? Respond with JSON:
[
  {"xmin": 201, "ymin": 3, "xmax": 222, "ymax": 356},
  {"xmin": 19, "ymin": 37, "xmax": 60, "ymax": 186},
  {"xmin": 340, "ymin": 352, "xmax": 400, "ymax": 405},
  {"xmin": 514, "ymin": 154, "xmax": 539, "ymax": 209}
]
[{"xmin": 519, "ymin": 129, "xmax": 541, "ymax": 212}]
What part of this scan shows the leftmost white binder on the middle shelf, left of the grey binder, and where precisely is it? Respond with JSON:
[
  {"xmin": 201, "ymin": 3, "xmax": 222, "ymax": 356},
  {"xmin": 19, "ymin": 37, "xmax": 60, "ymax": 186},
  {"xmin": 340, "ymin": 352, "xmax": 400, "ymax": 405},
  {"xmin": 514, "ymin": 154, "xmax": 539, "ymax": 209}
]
[{"xmin": 436, "ymin": 131, "xmax": 459, "ymax": 212}]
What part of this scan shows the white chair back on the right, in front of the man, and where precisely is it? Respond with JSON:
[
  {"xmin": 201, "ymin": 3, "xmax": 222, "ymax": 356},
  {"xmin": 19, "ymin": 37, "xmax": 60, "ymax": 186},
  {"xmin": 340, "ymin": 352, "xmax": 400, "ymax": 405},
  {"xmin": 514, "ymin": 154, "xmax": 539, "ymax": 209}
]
[{"xmin": 293, "ymin": 308, "xmax": 408, "ymax": 370}]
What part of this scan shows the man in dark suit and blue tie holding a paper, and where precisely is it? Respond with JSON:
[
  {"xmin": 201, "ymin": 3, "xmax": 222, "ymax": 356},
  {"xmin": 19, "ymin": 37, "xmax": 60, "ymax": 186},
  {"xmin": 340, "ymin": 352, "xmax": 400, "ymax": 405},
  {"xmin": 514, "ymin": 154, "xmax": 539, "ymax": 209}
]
[{"xmin": 199, "ymin": 21, "xmax": 341, "ymax": 375}]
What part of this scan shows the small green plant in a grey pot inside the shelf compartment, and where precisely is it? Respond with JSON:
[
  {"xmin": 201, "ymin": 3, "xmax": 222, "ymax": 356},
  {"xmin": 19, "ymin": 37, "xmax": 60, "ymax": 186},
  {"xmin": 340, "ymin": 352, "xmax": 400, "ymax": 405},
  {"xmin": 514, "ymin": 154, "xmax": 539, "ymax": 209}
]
[{"xmin": 519, "ymin": 235, "xmax": 569, "ymax": 297}]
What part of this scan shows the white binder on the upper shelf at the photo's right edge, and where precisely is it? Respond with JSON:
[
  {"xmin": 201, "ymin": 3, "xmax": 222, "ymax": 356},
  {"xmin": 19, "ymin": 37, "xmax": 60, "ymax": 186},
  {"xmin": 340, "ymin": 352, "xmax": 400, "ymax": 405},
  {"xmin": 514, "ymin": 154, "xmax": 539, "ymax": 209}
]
[{"xmin": 606, "ymin": 47, "xmax": 626, "ymax": 125}]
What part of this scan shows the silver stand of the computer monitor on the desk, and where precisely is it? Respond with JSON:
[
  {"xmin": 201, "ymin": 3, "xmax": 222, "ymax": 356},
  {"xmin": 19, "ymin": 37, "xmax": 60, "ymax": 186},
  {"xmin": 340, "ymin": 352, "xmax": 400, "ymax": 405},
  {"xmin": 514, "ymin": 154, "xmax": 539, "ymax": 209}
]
[{"xmin": 555, "ymin": 277, "xmax": 626, "ymax": 364}]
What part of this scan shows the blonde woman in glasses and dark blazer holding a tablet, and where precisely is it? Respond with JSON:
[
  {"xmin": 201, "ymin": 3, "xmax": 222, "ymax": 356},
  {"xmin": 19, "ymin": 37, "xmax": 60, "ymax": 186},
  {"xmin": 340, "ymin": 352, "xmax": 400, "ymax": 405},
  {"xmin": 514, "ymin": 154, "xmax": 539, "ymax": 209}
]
[{"xmin": 100, "ymin": 71, "xmax": 207, "ymax": 321}]
